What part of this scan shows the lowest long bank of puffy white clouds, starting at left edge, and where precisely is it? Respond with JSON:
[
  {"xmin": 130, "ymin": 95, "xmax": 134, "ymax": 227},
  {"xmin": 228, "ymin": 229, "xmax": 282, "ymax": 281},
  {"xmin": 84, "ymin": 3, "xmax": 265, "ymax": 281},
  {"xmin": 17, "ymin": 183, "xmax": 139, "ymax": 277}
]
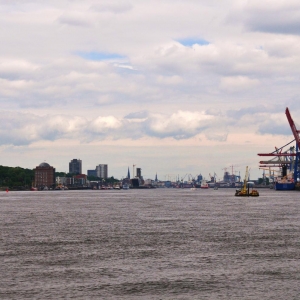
[{"xmin": 0, "ymin": 111, "xmax": 213, "ymax": 145}]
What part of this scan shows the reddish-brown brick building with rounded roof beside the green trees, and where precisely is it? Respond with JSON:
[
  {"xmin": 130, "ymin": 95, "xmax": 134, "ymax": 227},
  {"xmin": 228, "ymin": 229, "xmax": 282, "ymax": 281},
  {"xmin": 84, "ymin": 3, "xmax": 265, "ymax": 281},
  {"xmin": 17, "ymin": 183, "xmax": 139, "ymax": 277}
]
[{"xmin": 34, "ymin": 162, "xmax": 55, "ymax": 189}]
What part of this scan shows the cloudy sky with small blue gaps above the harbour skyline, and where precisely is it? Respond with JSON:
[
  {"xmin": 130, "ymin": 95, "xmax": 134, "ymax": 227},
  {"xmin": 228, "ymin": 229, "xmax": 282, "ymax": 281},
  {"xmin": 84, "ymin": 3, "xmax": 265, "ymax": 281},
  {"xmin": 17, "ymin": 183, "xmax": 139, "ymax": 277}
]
[{"xmin": 0, "ymin": 0, "xmax": 300, "ymax": 180}]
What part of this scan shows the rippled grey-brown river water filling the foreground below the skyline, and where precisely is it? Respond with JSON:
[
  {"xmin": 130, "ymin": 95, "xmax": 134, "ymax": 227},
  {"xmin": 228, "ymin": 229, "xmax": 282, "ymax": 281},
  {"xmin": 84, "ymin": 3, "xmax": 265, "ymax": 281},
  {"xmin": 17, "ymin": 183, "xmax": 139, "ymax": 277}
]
[{"xmin": 0, "ymin": 189, "xmax": 300, "ymax": 300}]
